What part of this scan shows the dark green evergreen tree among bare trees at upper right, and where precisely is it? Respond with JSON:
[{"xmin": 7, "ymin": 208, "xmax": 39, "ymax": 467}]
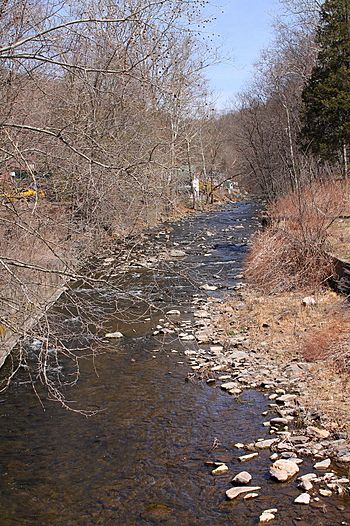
[{"xmin": 301, "ymin": 0, "xmax": 350, "ymax": 176}]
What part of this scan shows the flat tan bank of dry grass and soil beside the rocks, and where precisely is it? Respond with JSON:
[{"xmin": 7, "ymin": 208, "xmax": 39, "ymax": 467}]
[{"xmin": 215, "ymin": 288, "xmax": 350, "ymax": 439}]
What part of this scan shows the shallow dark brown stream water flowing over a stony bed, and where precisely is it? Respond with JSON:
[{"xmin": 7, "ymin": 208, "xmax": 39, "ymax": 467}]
[{"xmin": 0, "ymin": 202, "xmax": 350, "ymax": 526}]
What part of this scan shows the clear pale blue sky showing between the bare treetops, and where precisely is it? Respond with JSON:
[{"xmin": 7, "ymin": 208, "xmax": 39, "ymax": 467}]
[{"xmin": 205, "ymin": 0, "xmax": 282, "ymax": 109}]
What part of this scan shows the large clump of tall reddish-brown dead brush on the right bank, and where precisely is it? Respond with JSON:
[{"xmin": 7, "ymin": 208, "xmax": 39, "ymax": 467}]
[{"xmin": 245, "ymin": 181, "xmax": 349, "ymax": 293}]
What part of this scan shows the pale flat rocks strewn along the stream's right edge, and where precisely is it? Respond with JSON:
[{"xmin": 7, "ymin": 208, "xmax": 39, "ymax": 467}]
[{"xmin": 155, "ymin": 284, "xmax": 350, "ymax": 523}]
